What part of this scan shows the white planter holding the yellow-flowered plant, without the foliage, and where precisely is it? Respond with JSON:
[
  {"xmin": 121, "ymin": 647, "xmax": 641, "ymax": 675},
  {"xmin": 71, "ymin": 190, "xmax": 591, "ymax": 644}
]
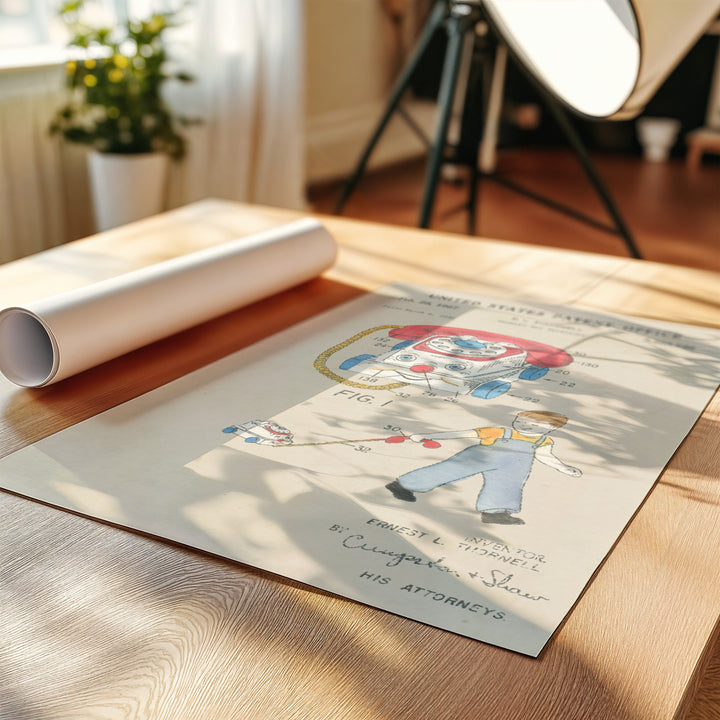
[{"xmin": 88, "ymin": 151, "xmax": 168, "ymax": 231}]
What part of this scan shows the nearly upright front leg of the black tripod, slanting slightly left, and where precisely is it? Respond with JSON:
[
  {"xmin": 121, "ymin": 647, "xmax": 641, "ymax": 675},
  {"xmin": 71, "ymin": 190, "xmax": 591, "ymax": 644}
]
[{"xmin": 418, "ymin": 9, "xmax": 474, "ymax": 228}]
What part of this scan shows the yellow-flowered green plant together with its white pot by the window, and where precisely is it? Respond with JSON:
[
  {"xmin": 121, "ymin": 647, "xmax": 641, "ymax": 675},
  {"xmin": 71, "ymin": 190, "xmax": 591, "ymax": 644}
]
[{"xmin": 50, "ymin": 0, "xmax": 192, "ymax": 230}]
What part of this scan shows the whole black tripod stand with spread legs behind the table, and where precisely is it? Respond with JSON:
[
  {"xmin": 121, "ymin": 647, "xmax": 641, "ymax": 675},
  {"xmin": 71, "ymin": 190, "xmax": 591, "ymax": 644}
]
[{"xmin": 335, "ymin": 0, "xmax": 642, "ymax": 258}]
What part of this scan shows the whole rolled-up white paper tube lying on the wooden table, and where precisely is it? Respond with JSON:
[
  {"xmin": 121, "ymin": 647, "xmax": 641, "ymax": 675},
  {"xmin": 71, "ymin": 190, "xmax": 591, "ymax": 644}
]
[{"xmin": 0, "ymin": 218, "xmax": 337, "ymax": 387}]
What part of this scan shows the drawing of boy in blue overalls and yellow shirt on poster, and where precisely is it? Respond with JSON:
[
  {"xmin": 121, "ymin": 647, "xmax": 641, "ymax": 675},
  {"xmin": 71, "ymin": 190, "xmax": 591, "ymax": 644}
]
[{"xmin": 385, "ymin": 410, "xmax": 582, "ymax": 525}]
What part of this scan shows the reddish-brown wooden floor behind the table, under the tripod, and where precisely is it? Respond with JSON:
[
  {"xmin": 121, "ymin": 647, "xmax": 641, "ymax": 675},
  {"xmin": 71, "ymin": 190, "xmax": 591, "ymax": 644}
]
[{"xmin": 310, "ymin": 149, "xmax": 720, "ymax": 270}]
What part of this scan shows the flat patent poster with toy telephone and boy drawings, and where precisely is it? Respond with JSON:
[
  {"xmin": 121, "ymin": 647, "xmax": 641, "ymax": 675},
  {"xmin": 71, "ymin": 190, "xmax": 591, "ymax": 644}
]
[{"xmin": 0, "ymin": 286, "xmax": 720, "ymax": 656}]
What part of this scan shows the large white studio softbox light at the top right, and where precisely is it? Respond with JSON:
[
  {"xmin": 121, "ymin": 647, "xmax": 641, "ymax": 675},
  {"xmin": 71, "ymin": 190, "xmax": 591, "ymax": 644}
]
[{"xmin": 483, "ymin": 0, "xmax": 720, "ymax": 120}]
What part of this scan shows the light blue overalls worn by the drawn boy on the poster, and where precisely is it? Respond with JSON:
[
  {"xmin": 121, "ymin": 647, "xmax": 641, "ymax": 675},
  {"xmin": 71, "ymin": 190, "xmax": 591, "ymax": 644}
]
[{"xmin": 397, "ymin": 428, "xmax": 547, "ymax": 513}]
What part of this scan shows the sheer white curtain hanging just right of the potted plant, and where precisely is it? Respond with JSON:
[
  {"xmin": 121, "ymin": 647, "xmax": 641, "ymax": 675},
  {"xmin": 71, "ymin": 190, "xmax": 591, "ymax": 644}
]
[{"xmin": 170, "ymin": 0, "xmax": 305, "ymax": 208}]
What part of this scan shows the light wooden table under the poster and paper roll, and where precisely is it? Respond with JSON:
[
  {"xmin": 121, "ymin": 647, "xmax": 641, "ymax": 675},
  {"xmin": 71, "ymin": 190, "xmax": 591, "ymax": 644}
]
[{"xmin": 0, "ymin": 201, "xmax": 720, "ymax": 720}]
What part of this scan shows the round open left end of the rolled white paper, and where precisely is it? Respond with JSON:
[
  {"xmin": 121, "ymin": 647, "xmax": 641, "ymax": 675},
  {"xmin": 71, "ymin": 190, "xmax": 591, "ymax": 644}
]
[{"xmin": 0, "ymin": 307, "xmax": 59, "ymax": 387}]
